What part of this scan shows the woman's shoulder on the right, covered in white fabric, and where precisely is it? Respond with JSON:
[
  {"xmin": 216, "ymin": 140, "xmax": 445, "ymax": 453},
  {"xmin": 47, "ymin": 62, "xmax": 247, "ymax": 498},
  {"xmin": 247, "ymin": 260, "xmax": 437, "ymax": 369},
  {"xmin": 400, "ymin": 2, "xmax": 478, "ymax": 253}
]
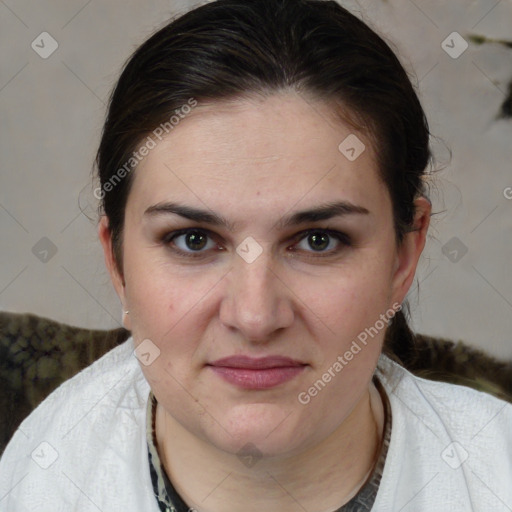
[{"xmin": 376, "ymin": 355, "xmax": 512, "ymax": 512}]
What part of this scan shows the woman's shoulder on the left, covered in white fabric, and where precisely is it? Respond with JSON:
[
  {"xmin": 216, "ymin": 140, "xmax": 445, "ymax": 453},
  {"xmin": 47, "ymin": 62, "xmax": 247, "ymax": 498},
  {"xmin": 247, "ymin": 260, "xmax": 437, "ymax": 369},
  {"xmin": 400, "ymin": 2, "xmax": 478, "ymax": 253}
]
[{"xmin": 0, "ymin": 338, "xmax": 157, "ymax": 511}]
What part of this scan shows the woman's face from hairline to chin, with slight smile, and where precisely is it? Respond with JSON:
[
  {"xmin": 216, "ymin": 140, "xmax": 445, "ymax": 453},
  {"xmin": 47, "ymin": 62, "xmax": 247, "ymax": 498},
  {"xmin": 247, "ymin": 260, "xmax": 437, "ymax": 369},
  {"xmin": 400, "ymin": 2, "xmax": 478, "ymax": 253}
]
[{"xmin": 100, "ymin": 93, "xmax": 428, "ymax": 454}]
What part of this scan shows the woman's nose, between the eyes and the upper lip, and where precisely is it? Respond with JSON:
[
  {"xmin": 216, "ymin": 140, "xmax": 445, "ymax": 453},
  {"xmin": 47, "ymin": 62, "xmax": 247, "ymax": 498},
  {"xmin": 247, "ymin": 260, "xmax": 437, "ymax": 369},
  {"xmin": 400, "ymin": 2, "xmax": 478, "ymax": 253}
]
[{"xmin": 220, "ymin": 246, "xmax": 294, "ymax": 343}]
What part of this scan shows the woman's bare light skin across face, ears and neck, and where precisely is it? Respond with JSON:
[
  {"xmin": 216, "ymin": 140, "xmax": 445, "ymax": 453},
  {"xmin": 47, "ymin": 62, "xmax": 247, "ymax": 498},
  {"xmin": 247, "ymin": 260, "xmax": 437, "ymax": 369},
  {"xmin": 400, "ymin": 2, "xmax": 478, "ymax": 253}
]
[{"xmin": 99, "ymin": 92, "xmax": 430, "ymax": 512}]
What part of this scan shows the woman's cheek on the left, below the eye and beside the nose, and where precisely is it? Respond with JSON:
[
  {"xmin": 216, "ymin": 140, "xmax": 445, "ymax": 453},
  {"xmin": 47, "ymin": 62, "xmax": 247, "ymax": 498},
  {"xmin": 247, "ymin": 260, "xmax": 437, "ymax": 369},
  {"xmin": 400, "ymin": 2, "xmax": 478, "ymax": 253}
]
[{"xmin": 127, "ymin": 256, "xmax": 218, "ymax": 384}]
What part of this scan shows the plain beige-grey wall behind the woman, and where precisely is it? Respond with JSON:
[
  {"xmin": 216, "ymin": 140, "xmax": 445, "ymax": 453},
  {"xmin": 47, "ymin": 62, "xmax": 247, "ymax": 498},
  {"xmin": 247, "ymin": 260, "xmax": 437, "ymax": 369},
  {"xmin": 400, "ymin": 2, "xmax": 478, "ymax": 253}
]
[{"xmin": 0, "ymin": 0, "xmax": 512, "ymax": 358}]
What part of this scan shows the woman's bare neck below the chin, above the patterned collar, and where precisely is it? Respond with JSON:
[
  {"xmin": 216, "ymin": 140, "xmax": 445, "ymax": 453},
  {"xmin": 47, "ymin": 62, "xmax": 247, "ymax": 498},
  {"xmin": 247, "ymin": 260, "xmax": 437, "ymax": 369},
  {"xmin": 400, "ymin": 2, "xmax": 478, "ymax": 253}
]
[{"xmin": 156, "ymin": 383, "xmax": 384, "ymax": 512}]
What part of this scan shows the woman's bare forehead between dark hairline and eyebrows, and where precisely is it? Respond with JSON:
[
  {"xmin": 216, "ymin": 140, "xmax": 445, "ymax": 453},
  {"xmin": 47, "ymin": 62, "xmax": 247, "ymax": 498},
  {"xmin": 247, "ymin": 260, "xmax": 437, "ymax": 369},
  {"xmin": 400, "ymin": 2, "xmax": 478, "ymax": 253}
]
[{"xmin": 128, "ymin": 93, "xmax": 388, "ymax": 218}]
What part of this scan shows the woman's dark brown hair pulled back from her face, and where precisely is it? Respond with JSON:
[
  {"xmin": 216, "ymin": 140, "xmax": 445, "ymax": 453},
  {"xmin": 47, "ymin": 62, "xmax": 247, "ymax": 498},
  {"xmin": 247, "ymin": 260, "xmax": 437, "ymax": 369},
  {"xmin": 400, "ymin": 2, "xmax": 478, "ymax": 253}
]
[{"xmin": 96, "ymin": 0, "xmax": 431, "ymax": 362}]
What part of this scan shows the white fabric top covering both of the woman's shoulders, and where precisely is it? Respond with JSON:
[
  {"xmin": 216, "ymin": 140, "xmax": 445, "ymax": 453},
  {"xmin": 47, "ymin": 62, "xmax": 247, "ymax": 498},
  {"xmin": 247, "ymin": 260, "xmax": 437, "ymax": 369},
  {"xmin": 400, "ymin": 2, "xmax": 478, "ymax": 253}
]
[{"xmin": 0, "ymin": 338, "xmax": 512, "ymax": 512}]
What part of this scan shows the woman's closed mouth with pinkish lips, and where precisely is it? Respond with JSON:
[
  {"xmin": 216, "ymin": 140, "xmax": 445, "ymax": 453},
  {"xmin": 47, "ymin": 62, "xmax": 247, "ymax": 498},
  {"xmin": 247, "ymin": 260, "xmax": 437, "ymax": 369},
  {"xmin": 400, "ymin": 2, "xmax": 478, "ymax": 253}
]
[{"xmin": 207, "ymin": 356, "xmax": 308, "ymax": 390}]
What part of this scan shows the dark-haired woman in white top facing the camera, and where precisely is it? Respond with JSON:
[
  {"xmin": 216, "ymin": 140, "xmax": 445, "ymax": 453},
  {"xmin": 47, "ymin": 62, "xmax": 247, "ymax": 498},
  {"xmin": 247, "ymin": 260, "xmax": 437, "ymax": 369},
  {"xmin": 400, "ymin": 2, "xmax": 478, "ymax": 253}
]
[{"xmin": 0, "ymin": 0, "xmax": 512, "ymax": 512}]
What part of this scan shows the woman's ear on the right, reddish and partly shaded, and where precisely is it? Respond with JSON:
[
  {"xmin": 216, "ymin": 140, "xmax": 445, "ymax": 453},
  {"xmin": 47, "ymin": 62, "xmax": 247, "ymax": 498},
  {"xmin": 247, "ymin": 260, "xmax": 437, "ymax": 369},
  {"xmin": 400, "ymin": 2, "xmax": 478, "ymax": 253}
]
[{"xmin": 392, "ymin": 197, "xmax": 432, "ymax": 304}]
